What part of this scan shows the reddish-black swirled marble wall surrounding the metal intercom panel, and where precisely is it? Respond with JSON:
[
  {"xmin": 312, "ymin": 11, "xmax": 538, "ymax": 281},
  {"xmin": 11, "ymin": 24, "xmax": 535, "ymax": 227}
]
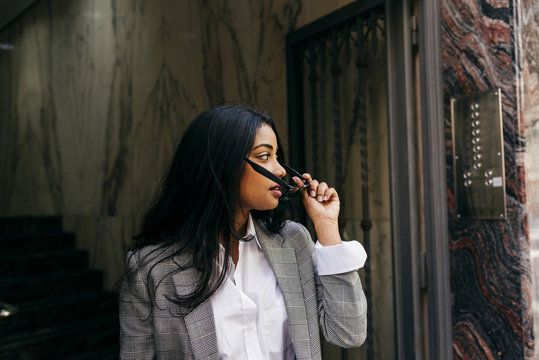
[{"xmin": 442, "ymin": 0, "xmax": 537, "ymax": 359}]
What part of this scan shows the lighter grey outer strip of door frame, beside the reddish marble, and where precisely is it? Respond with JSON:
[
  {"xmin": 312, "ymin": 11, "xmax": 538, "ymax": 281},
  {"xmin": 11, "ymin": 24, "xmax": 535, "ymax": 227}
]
[{"xmin": 417, "ymin": 0, "xmax": 453, "ymax": 360}]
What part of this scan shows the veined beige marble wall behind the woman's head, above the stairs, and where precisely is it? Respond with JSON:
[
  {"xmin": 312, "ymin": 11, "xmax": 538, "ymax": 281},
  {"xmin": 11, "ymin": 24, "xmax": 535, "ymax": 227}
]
[{"xmin": 0, "ymin": 0, "xmax": 352, "ymax": 287}]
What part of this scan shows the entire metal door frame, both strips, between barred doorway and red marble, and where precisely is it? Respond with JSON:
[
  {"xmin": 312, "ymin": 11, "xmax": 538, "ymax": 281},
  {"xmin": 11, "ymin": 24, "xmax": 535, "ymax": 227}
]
[{"xmin": 386, "ymin": 0, "xmax": 453, "ymax": 360}]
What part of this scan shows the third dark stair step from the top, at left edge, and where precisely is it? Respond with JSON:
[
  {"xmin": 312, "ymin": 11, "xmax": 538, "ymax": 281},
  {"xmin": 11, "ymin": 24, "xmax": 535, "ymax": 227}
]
[{"xmin": 0, "ymin": 249, "xmax": 88, "ymax": 279}]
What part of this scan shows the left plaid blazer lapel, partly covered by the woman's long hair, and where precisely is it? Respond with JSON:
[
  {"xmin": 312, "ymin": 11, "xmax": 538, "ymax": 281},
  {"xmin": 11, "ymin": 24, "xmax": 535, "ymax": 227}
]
[{"xmin": 172, "ymin": 261, "xmax": 219, "ymax": 360}]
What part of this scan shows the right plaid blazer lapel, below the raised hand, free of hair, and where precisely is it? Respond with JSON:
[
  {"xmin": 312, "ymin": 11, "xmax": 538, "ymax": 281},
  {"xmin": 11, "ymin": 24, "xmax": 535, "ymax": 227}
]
[{"xmin": 254, "ymin": 221, "xmax": 311, "ymax": 359}]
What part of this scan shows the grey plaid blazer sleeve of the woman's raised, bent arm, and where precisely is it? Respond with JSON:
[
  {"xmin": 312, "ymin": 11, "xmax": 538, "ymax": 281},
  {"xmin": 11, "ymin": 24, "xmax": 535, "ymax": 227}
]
[{"xmin": 302, "ymin": 226, "xmax": 367, "ymax": 348}]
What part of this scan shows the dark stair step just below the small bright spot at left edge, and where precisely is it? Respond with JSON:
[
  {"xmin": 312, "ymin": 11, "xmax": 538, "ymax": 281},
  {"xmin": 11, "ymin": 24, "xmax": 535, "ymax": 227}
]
[{"xmin": 0, "ymin": 291, "xmax": 118, "ymax": 338}]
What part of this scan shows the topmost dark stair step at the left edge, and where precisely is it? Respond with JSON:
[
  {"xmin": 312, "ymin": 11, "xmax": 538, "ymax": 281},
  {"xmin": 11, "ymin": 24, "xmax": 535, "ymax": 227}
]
[{"xmin": 0, "ymin": 216, "xmax": 62, "ymax": 234}]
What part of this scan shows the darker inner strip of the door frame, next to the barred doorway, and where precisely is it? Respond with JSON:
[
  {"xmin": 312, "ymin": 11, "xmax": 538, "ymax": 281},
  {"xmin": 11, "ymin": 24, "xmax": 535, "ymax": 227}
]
[{"xmin": 386, "ymin": 0, "xmax": 424, "ymax": 360}]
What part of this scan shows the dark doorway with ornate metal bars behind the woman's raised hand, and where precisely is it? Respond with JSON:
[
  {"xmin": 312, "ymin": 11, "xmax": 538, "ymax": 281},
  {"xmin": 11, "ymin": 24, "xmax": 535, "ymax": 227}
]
[{"xmin": 288, "ymin": 2, "xmax": 395, "ymax": 359}]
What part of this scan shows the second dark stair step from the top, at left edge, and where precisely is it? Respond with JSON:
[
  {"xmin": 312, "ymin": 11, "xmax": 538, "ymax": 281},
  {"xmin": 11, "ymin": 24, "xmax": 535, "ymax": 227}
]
[{"xmin": 0, "ymin": 231, "xmax": 75, "ymax": 255}]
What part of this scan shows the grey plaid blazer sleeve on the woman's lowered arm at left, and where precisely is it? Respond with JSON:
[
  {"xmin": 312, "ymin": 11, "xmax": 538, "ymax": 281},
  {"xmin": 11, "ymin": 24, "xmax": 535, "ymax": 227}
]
[{"xmin": 120, "ymin": 252, "xmax": 155, "ymax": 359}]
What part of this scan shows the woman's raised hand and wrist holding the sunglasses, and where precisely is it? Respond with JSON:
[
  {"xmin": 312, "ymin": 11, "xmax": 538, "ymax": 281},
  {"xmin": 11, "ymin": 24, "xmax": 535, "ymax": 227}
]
[{"xmin": 294, "ymin": 174, "xmax": 341, "ymax": 246}]
